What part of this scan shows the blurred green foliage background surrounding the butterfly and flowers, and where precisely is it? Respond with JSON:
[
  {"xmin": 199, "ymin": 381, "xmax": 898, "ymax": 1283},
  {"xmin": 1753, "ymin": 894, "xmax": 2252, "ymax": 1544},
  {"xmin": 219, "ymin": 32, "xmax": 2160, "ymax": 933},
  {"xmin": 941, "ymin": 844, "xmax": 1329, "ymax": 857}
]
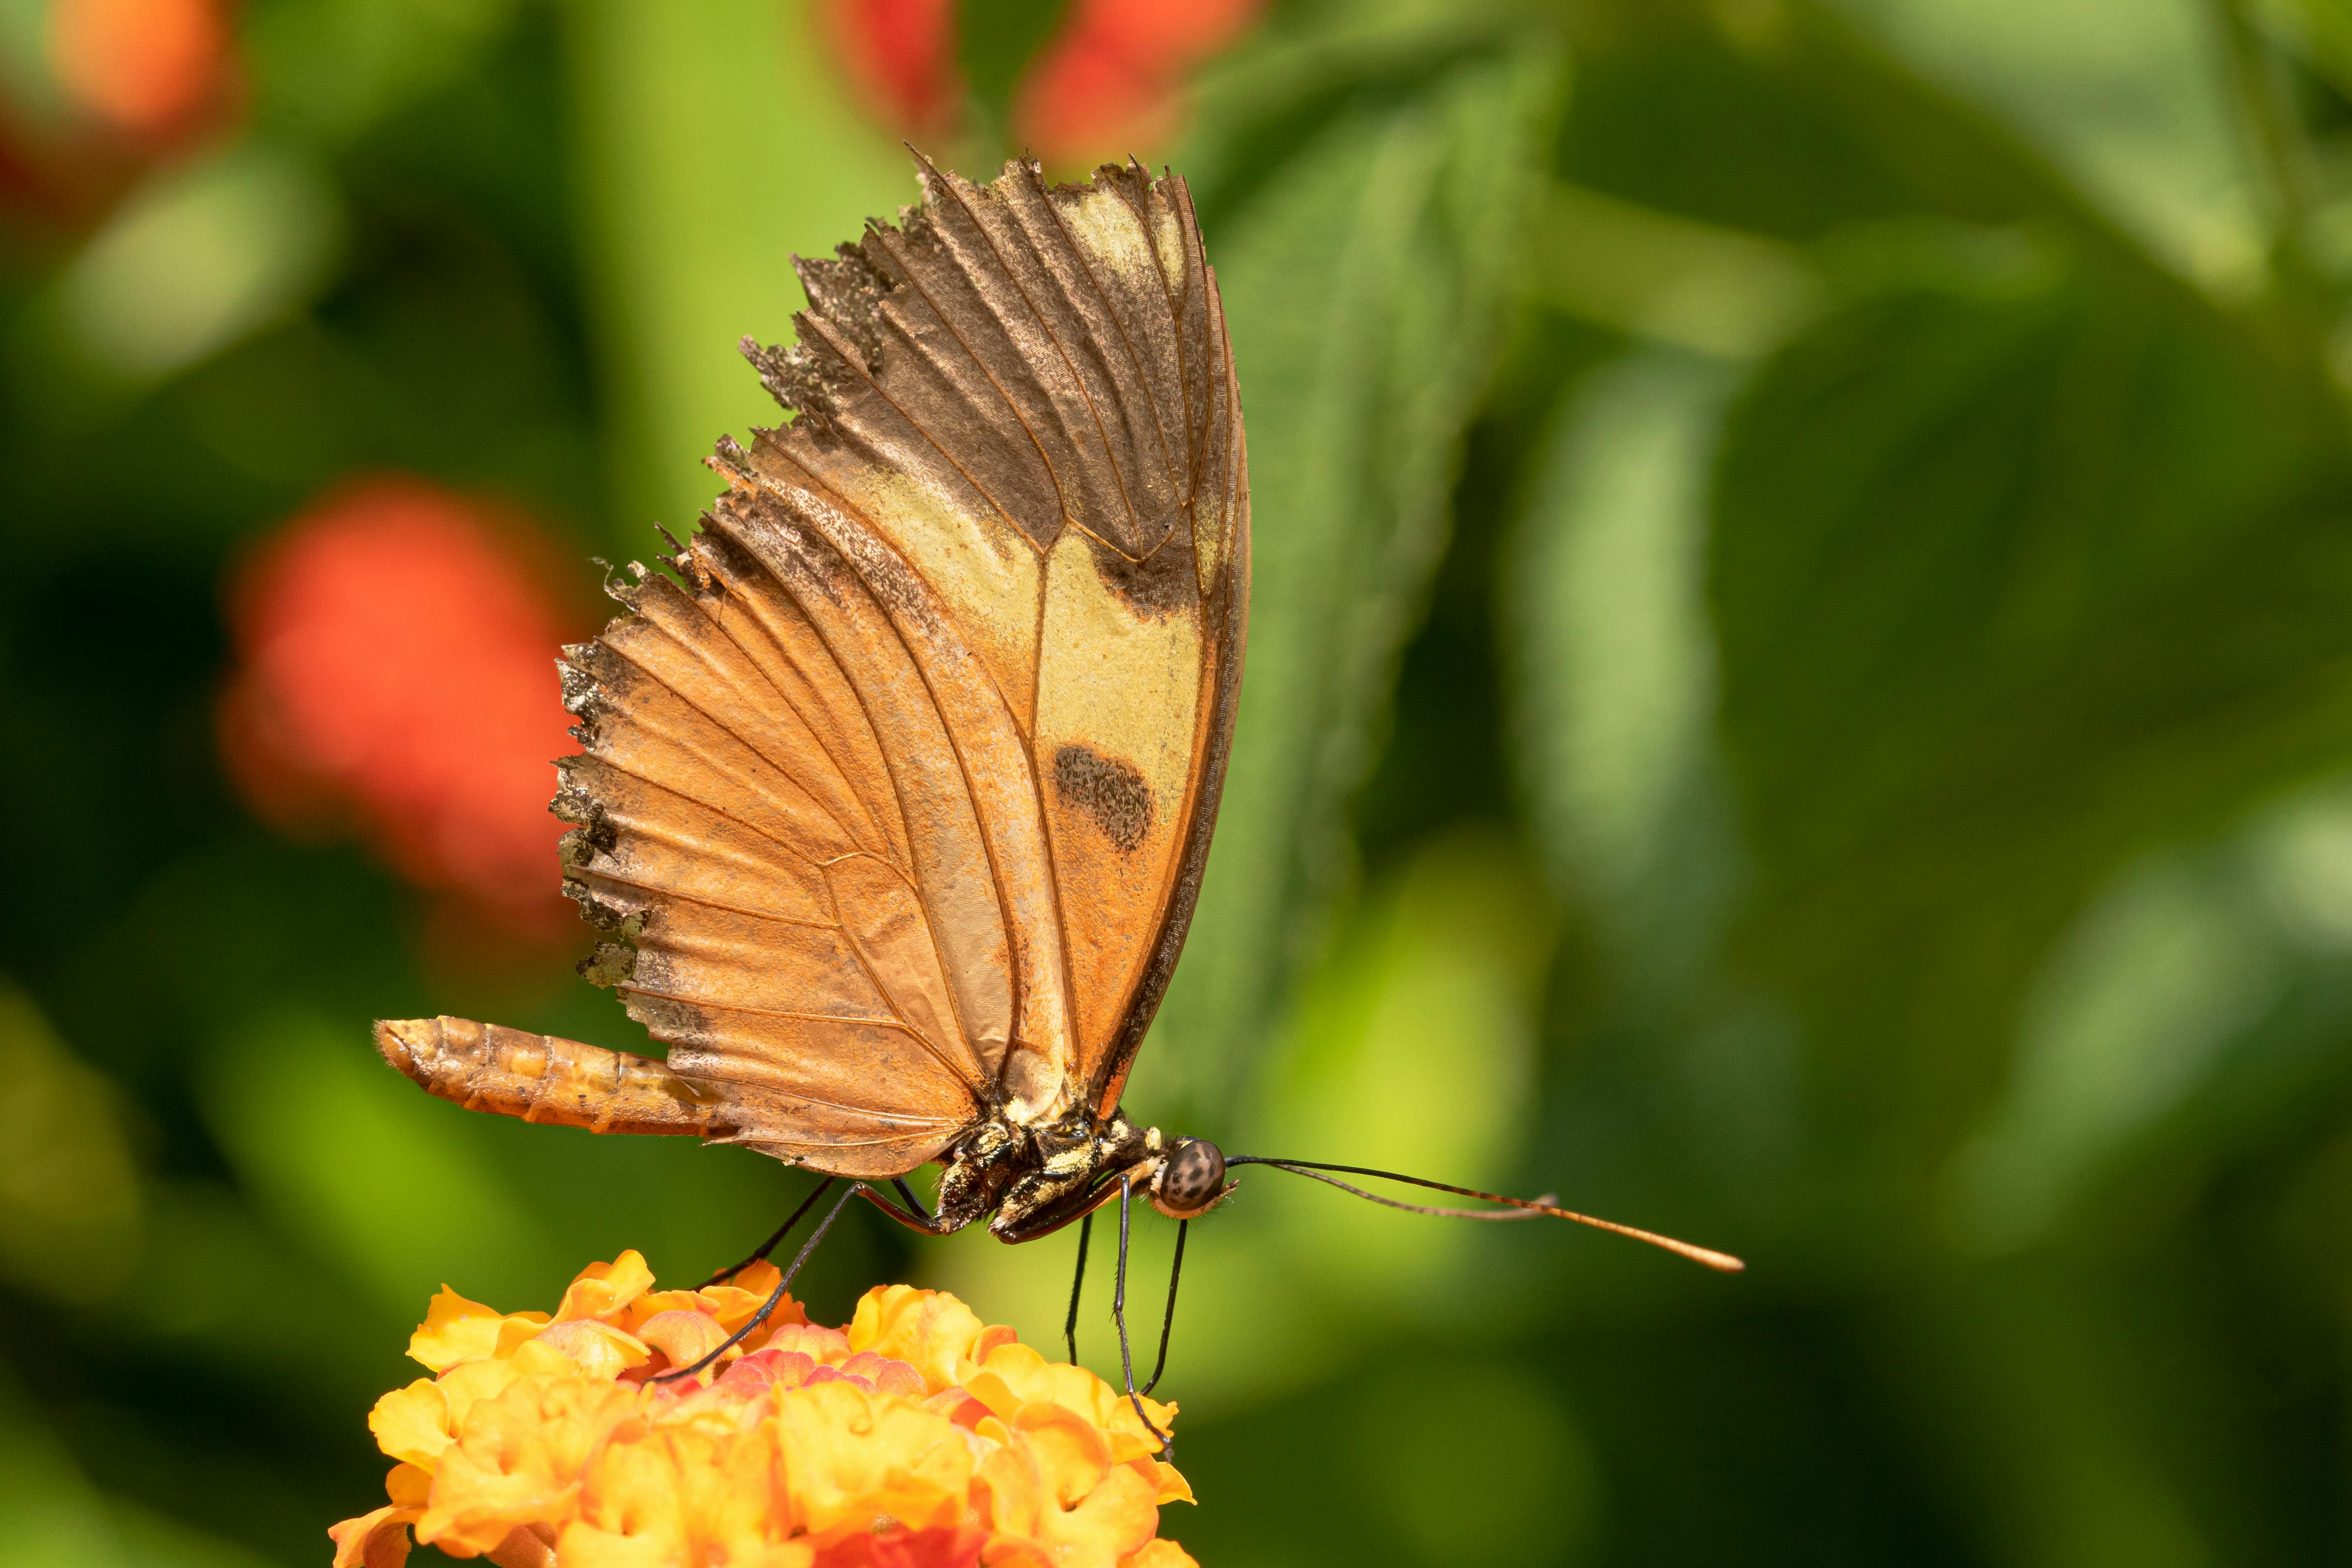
[{"xmin": 14, "ymin": 0, "xmax": 2352, "ymax": 1568}]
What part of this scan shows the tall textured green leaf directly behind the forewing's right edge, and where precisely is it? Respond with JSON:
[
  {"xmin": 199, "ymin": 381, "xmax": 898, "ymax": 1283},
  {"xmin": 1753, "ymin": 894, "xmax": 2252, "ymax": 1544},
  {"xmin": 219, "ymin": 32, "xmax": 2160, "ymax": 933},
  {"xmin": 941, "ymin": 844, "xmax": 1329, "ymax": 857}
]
[{"xmin": 1136, "ymin": 28, "xmax": 1559, "ymax": 1117}]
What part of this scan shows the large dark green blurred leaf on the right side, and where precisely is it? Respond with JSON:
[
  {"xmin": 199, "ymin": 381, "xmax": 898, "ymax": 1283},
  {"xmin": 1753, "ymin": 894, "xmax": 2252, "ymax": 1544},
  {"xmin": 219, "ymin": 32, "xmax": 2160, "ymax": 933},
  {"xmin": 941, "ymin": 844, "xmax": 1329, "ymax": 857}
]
[{"xmin": 1710, "ymin": 245, "xmax": 2352, "ymax": 1194}]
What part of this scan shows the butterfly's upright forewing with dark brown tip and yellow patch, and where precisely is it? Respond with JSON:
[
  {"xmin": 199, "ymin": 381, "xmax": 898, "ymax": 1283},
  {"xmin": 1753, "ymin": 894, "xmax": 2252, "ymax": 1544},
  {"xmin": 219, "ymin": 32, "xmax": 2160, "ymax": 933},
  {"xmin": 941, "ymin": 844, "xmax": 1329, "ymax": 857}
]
[{"xmin": 734, "ymin": 165, "xmax": 1249, "ymax": 1112}]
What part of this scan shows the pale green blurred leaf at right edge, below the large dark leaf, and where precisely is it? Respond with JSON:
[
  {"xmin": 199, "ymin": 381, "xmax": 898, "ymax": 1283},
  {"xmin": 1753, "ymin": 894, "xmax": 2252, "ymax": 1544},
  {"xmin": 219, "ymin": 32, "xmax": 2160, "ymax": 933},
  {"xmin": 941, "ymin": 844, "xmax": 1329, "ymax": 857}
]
[{"xmin": 1945, "ymin": 780, "xmax": 2352, "ymax": 1255}]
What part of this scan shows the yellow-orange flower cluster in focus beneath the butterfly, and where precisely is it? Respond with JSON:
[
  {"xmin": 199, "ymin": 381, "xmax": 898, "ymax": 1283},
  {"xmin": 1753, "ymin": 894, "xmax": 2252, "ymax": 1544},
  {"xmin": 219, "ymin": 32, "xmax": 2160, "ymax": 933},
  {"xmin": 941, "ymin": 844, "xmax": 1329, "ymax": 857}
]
[{"xmin": 329, "ymin": 1250, "xmax": 1197, "ymax": 1568}]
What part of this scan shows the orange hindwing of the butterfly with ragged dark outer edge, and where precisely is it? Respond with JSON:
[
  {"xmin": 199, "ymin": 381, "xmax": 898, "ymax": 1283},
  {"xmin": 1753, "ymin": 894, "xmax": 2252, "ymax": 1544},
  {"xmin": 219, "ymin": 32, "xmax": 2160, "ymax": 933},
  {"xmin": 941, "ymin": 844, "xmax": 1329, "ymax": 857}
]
[{"xmin": 557, "ymin": 515, "xmax": 1009, "ymax": 1173}]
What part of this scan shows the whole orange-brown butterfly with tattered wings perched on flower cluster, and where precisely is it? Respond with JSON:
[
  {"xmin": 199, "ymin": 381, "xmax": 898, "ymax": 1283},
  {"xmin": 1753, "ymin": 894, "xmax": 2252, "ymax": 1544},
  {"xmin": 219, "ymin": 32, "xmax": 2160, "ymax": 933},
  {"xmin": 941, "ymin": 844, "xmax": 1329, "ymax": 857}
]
[{"xmin": 376, "ymin": 155, "xmax": 1738, "ymax": 1415}]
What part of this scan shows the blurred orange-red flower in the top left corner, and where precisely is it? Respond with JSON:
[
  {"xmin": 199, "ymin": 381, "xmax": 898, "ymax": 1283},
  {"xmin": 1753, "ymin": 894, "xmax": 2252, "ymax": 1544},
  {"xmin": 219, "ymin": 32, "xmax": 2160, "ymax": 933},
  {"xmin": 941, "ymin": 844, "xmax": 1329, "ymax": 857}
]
[{"xmin": 49, "ymin": 0, "xmax": 235, "ymax": 141}]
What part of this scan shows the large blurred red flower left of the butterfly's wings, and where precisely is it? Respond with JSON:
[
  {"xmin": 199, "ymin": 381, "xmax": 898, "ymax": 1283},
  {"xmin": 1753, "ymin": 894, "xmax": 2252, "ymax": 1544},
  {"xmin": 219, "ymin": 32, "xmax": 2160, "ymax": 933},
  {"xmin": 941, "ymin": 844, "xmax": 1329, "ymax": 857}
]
[{"xmin": 219, "ymin": 477, "xmax": 579, "ymax": 938}]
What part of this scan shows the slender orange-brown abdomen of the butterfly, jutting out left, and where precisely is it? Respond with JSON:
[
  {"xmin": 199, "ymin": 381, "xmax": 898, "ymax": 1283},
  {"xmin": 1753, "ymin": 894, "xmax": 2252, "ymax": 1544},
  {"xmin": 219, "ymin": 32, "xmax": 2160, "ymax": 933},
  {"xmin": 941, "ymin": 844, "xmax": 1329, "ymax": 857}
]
[{"xmin": 376, "ymin": 1018, "xmax": 727, "ymax": 1138}]
